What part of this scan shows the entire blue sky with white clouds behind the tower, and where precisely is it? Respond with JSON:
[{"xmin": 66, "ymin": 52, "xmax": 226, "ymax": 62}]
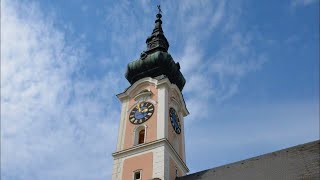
[{"xmin": 1, "ymin": 0, "xmax": 319, "ymax": 180}]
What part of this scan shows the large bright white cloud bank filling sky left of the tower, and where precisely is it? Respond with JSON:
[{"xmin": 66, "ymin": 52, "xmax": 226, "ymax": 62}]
[{"xmin": 1, "ymin": 1, "xmax": 119, "ymax": 179}]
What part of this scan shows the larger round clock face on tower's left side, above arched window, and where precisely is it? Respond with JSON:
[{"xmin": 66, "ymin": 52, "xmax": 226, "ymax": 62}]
[{"xmin": 129, "ymin": 101, "xmax": 154, "ymax": 124}]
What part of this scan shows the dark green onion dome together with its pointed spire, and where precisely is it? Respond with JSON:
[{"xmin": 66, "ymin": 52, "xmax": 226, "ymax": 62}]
[{"xmin": 125, "ymin": 11, "xmax": 186, "ymax": 91}]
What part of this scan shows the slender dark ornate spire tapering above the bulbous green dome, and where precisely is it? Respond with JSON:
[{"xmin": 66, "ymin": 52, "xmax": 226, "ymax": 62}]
[{"xmin": 146, "ymin": 5, "xmax": 169, "ymax": 54}]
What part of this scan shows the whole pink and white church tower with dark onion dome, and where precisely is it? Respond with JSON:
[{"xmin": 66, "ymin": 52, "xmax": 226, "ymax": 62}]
[{"xmin": 112, "ymin": 7, "xmax": 189, "ymax": 180}]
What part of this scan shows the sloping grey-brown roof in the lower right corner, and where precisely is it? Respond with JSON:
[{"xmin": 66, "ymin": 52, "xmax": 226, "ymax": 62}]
[{"xmin": 177, "ymin": 140, "xmax": 320, "ymax": 180}]
